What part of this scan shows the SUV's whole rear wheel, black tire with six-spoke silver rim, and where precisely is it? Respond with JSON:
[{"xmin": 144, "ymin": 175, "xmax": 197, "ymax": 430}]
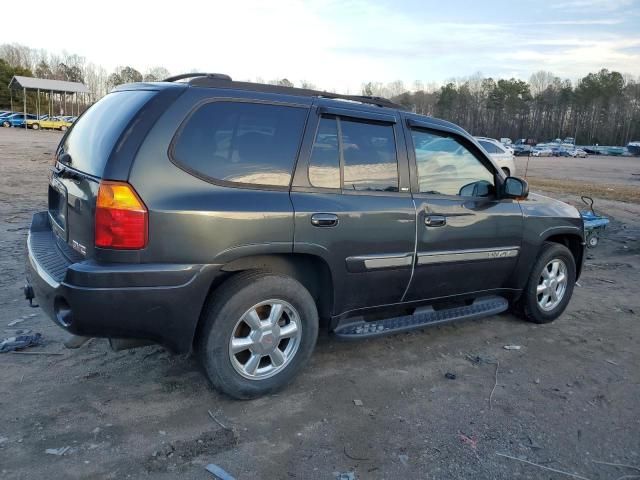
[{"xmin": 198, "ymin": 272, "xmax": 318, "ymax": 399}]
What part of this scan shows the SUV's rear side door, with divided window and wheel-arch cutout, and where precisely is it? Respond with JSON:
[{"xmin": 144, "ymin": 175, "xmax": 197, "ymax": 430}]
[{"xmin": 291, "ymin": 101, "xmax": 415, "ymax": 315}]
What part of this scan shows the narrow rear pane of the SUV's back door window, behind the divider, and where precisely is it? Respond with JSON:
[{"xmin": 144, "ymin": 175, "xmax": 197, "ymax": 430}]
[{"xmin": 309, "ymin": 117, "xmax": 340, "ymax": 188}]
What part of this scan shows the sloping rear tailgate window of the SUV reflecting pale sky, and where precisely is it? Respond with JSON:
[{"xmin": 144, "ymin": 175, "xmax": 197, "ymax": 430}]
[{"xmin": 62, "ymin": 90, "xmax": 157, "ymax": 177}]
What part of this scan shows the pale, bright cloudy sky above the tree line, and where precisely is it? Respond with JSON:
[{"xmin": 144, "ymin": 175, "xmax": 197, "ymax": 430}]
[{"xmin": 0, "ymin": 0, "xmax": 640, "ymax": 93}]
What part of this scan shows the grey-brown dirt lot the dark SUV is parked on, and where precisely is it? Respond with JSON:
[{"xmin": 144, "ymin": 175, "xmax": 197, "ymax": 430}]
[{"xmin": 0, "ymin": 129, "xmax": 640, "ymax": 480}]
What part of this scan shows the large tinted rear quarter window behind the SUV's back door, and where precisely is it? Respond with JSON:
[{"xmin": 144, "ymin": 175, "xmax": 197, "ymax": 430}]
[{"xmin": 173, "ymin": 102, "xmax": 307, "ymax": 186}]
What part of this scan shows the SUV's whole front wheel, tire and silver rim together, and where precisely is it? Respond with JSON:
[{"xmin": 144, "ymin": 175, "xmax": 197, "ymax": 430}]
[{"xmin": 519, "ymin": 242, "xmax": 576, "ymax": 323}]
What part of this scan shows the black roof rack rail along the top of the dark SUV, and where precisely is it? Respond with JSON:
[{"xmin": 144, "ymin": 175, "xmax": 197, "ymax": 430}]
[{"xmin": 180, "ymin": 73, "xmax": 406, "ymax": 110}]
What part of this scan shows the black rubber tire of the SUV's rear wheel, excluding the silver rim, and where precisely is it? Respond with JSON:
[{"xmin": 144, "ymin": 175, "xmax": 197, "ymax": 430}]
[{"xmin": 196, "ymin": 271, "xmax": 318, "ymax": 399}]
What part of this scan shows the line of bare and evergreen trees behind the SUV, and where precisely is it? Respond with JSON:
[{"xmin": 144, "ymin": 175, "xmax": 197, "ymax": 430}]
[{"xmin": 0, "ymin": 44, "xmax": 640, "ymax": 145}]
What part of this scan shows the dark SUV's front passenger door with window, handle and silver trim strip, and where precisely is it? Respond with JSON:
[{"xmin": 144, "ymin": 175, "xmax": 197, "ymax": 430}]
[{"xmin": 404, "ymin": 120, "xmax": 522, "ymax": 301}]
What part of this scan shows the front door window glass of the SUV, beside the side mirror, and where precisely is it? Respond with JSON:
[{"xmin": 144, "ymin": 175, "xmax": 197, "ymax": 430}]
[{"xmin": 411, "ymin": 130, "xmax": 494, "ymax": 196}]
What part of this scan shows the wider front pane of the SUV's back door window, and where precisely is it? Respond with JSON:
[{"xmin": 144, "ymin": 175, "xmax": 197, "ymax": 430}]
[{"xmin": 340, "ymin": 119, "xmax": 398, "ymax": 192}]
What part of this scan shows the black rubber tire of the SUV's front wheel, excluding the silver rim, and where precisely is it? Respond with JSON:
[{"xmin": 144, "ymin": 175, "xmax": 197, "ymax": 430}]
[{"xmin": 515, "ymin": 242, "xmax": 576, "ymax": 323}]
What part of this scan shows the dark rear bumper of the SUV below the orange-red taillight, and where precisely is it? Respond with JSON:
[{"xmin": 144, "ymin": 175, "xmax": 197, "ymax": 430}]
[{"xmin": 27, "ymin": 212, "xmax": 221, "ymax": 353}]
